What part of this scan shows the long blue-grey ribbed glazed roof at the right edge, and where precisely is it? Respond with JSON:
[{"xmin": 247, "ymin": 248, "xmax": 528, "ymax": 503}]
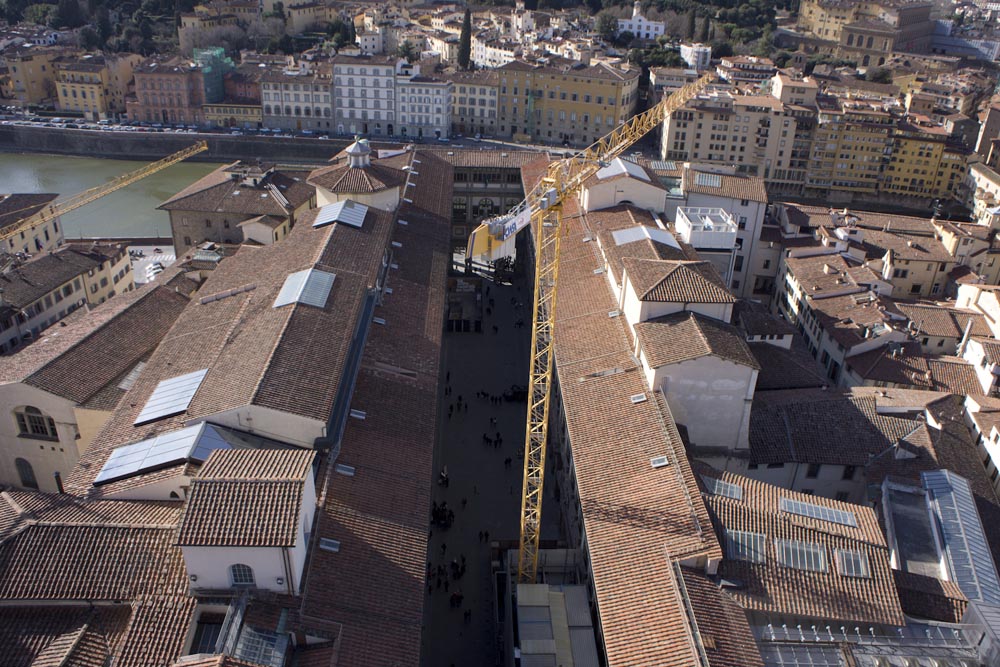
[{"xmin": 921, "ymin": 470, "xmax": 1000, "ymax": 605}]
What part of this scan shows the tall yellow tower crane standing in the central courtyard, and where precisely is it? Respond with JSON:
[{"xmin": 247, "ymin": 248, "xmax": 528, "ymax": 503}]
[{"xmin": 466, "ymin": 74, "xmax": 715, "ymax": 584}]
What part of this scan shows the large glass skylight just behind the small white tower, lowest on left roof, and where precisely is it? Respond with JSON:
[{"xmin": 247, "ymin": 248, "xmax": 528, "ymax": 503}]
[{"xmin": 94, "ymin": 422, "xmax": 231, "ymax": 486}]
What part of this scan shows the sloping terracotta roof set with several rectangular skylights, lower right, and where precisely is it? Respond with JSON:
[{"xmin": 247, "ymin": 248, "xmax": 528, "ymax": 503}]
[{"xmin": 699, "ymin": 467, "xmax": 905, "ymax": 626}]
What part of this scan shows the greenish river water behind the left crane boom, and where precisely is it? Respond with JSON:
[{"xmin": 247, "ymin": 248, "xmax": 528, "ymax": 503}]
[{"xmin": 0, "ymin": 153, "xmax": 219, "ymax": 238}]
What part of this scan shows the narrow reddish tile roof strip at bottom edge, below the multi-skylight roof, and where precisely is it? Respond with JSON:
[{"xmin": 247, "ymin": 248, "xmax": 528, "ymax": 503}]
[{"xmin": 681, "ymin": 568, "xmax": 764, "ymax": 667}]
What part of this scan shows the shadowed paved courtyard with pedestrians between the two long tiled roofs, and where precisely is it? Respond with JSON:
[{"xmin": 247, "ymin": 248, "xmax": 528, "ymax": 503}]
[{"xmin": 421, "ymin": 272, "xmax": 559, "ymax": 667}]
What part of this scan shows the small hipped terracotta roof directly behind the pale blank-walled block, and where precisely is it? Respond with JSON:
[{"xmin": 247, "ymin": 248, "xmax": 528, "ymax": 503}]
[{"xmin": 622, "ymin": 257, "xmax": 736, "ymax": 303}]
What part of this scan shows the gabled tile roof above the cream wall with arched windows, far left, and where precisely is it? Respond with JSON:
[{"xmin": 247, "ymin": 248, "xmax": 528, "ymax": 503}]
[{"xmin": 0, "ymin": 286, "xmax": 188, "ymax": 404}]
